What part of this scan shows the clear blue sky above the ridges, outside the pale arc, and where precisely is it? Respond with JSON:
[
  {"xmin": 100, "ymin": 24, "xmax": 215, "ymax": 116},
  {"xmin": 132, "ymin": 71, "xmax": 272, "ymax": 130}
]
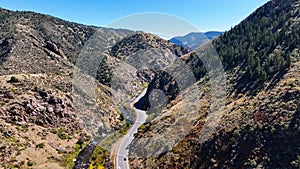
[{"xmin": 0, "ymin": 0, "xmax": 268, "ymax": 35}]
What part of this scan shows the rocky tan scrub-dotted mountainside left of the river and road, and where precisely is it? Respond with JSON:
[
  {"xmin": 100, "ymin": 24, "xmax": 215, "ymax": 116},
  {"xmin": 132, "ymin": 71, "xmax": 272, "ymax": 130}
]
[{"xmin": 0, "ymin": 8, "xmax": 188, "ymax": 168}]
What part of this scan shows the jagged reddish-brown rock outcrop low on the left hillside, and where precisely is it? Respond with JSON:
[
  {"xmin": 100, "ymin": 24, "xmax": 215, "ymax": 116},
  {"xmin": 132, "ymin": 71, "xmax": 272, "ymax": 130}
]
[{"xmin": 3, "ymin": 89, "xmax": 80, "ymax": 130}]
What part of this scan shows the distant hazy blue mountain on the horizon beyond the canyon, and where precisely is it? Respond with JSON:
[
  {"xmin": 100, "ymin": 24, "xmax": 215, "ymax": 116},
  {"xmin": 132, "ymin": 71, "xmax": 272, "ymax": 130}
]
[{"xmin": 170, "ymin": 31, "xmax": 224, "ymax": 50}]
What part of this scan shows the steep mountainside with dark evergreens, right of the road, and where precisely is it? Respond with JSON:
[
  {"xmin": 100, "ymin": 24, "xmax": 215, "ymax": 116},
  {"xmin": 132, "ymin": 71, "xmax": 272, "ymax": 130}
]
[{"xmin": 130, "ymin": 0, "xmax": 300, "ymax": 168}]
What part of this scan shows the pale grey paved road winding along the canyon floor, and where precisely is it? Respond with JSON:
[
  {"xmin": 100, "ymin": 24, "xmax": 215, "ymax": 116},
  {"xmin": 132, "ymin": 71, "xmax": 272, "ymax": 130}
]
[{"xmin": 115, "ymin": 89, "xmax": 148, "ymax": 169}]
